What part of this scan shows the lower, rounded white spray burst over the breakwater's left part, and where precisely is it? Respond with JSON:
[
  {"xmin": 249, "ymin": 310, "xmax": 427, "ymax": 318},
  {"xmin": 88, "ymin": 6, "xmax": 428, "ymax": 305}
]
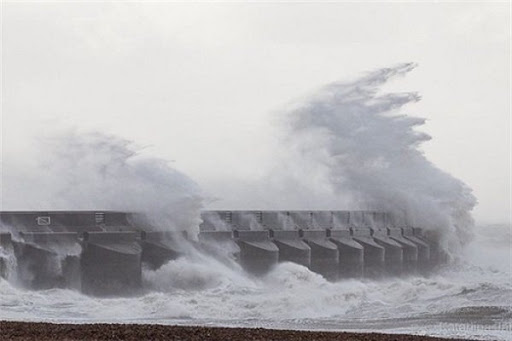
[{"xmin": 2, "ymin": 129, "xmax": 202, "ymax": 237}]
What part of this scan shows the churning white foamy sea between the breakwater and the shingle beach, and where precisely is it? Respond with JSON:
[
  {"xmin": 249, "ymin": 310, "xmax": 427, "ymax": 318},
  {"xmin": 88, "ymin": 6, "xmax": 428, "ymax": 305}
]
[{"xmin": 0, "ymin": 225, "xmax": 512, "ymax": 340}]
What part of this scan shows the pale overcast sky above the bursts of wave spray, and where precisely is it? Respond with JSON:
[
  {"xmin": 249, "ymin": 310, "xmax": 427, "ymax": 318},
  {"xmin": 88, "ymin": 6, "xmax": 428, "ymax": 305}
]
[{"xmin": 1, "ymin": 2, "xmax": 511, "ymax": 222}]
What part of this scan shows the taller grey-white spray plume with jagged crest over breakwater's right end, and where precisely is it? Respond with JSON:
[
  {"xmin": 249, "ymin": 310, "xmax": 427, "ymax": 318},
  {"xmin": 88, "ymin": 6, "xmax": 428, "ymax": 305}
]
[{"xmin": 206, "ymin": 63, "xmax": 477, "ymax": 252}]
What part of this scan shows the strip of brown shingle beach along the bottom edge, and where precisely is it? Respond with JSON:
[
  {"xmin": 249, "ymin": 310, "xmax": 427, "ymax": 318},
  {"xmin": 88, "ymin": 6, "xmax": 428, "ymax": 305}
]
[{"xmin": 0, "ymin": 321, "xmax": 472, "ymax": 341}]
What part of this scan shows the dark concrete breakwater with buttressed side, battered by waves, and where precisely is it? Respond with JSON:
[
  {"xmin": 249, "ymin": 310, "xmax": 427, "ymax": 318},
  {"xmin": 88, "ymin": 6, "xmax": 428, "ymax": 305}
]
[{"xmin": 0, "ymin": 211, "xmax": 441, "ymax": 295}]
